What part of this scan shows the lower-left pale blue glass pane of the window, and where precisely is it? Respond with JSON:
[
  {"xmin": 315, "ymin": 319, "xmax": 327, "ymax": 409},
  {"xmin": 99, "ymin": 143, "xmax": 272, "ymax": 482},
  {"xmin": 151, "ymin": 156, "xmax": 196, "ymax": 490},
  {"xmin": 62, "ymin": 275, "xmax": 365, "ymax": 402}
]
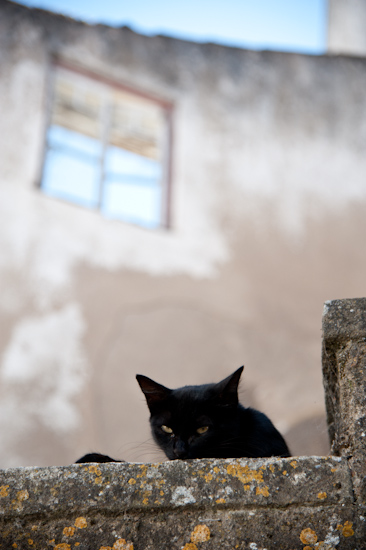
[{"xmin": 42, "ymin": 150, "xmax": 100, "ymax": 208}]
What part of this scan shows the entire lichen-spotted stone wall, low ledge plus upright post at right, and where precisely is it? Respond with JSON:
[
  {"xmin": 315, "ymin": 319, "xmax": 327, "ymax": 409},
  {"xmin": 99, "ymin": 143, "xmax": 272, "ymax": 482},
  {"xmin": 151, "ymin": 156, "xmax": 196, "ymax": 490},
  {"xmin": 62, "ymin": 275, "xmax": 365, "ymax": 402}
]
[{"xmin": 0, "ymin": 298, "xmax": 366, "ymax": 550}]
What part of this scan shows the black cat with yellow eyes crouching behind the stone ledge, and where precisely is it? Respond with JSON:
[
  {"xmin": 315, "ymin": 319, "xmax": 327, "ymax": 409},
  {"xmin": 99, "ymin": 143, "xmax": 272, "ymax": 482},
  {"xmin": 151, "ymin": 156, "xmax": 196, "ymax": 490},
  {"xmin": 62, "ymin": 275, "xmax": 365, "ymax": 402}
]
[{"xmin": 136, "ymin": 367, "xmax": 290, "ymax": 460}]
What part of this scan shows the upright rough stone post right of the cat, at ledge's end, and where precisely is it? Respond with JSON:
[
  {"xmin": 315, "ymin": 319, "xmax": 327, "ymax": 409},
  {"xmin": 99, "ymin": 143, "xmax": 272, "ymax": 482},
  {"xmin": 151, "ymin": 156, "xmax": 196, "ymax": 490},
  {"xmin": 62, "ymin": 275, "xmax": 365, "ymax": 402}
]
[{"xmin": 323, "ymin": 298, "xmax": 366, "ymax": 507}]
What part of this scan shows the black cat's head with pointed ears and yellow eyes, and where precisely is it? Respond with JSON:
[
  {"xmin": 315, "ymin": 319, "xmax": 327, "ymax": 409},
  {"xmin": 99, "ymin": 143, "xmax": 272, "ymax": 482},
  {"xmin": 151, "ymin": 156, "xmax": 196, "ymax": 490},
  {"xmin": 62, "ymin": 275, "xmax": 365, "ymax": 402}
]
[{"xmin": 136, "ymin": 367, "xmax": 244, "ymax": 460}]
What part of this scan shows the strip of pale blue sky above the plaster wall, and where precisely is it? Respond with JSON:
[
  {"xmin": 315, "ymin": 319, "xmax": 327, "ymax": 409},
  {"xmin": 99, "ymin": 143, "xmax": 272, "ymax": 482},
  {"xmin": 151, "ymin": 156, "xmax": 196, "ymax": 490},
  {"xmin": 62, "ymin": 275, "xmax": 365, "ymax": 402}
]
[{"xmin": 18, "ymin": 0, "xmax": 327, "ymax": 54}]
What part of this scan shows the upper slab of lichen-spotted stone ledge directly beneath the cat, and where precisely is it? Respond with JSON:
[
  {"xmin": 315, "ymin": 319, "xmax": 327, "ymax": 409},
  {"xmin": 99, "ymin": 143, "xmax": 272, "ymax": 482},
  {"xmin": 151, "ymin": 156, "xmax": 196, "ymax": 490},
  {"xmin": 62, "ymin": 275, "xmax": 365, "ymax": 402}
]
[{"xmin": 0, "ymin": 457, "xmax": 353, "ymax": 518}]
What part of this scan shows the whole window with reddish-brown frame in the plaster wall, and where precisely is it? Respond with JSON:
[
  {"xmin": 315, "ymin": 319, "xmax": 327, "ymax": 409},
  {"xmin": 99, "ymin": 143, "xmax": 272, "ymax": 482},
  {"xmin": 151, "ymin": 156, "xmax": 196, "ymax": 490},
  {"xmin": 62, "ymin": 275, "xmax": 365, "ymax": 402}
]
[{"xmin": 41, "ymin": 65, "xmax": 171, "ymax": 228}]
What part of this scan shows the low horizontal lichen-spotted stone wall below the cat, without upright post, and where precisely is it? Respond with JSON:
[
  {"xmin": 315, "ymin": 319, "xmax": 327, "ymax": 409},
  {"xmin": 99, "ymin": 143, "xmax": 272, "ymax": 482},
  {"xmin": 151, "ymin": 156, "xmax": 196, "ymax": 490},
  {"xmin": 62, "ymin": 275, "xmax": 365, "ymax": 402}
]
[{"xmin": 0, "ymin": 457, "xmax": 360, "ymax": 550}]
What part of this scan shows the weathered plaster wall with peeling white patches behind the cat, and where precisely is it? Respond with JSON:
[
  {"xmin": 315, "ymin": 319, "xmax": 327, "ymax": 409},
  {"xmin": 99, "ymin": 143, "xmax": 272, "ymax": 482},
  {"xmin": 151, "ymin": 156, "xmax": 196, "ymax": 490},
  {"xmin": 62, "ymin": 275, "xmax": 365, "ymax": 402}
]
[{"xmin": 0, "ymin": 1, "xmax": 366, "ymax": 466}]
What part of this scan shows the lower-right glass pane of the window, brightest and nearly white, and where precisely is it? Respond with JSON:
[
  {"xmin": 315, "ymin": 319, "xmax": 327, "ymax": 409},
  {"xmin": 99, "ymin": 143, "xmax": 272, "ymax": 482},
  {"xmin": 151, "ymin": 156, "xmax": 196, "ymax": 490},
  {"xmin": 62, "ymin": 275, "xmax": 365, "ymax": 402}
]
[{"xmin": 102, "ymin": 178, "xmax": 161, "ymax": 228}]
